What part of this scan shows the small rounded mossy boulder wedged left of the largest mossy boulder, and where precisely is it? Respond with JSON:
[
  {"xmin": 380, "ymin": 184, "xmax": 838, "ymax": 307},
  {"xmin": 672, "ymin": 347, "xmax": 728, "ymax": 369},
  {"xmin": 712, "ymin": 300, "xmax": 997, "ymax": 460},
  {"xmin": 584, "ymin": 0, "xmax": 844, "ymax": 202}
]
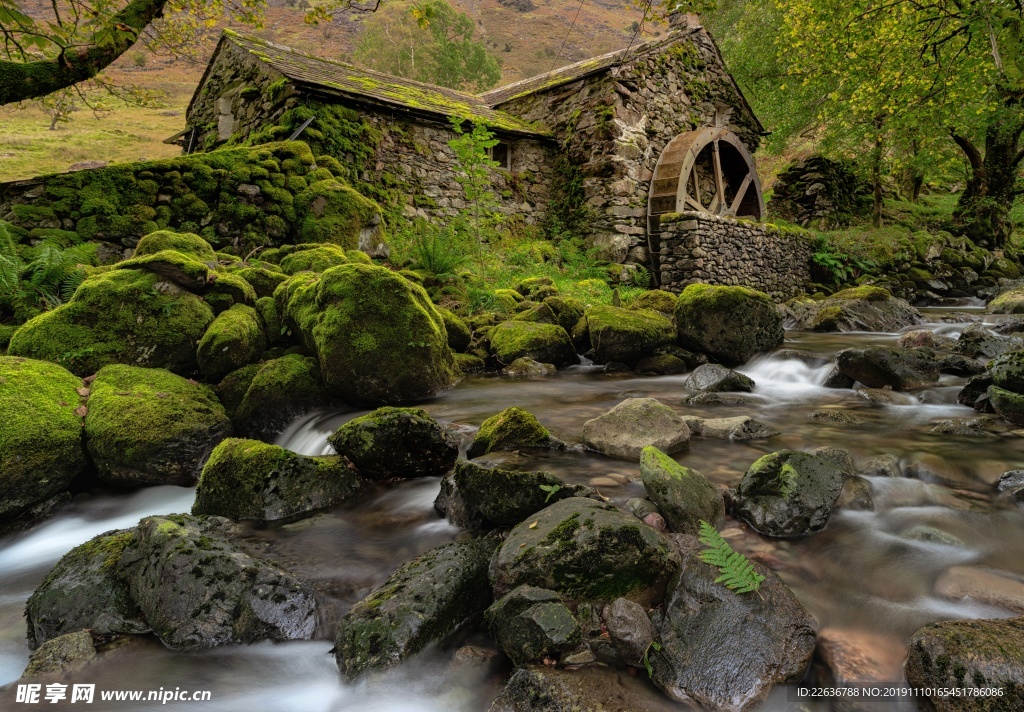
[{"xmin": 196, "ymin": 304, "xmax": 267, "ymax": 381}]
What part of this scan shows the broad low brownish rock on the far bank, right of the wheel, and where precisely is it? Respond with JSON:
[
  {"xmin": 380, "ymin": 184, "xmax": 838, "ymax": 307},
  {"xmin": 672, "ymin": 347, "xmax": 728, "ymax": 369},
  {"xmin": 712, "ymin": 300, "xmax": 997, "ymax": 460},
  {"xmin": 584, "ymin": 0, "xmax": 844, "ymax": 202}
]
[{"xmin": 797, "ymin": 287, "xmax": 925, "ymax": 332}]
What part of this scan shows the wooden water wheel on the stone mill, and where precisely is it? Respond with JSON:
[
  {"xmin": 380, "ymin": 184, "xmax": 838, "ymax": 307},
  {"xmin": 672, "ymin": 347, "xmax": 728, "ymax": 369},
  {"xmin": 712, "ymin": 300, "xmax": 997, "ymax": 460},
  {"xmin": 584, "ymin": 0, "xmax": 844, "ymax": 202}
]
[{"xmin": 648, "ymin": 128, "xmax": 765, "ymax": 225}]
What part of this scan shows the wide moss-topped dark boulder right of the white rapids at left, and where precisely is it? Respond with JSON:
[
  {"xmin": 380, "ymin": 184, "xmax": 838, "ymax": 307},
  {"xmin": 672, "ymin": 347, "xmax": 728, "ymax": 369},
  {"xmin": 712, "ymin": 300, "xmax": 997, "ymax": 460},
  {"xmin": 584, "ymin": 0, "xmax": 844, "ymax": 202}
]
[{"xmin": 193, "ymin": 437, "xmax": 362, "ymax": 521}]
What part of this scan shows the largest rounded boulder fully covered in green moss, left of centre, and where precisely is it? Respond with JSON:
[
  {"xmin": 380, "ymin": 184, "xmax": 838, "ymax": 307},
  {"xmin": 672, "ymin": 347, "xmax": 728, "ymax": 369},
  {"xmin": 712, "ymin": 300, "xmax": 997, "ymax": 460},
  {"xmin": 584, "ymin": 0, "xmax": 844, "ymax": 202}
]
[{"xmin": 275, "ymin": 263, "xmax": 461, "ymax": 405}]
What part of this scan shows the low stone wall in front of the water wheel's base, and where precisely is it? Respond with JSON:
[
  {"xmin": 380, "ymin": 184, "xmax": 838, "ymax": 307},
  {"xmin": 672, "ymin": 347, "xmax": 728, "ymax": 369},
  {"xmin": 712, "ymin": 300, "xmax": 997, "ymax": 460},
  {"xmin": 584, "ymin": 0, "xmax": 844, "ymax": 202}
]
[{"xmin": 655, "ymin": 212, "xmax": 813, "ymax": 301}]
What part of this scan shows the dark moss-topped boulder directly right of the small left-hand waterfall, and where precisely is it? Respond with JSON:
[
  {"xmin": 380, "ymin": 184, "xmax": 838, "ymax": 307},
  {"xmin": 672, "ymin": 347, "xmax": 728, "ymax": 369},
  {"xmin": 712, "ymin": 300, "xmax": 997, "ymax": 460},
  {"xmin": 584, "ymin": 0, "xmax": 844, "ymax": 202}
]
[{"xmin": 328, "ymin": 407, "xmax": 459, "ymax": 479}]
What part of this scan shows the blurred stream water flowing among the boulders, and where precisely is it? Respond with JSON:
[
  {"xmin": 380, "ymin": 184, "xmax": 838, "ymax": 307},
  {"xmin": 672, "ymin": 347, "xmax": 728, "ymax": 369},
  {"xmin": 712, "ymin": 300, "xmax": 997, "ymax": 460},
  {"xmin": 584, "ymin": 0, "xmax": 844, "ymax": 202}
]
[{"xmin": 0, "ymin": 303, "xmax": 1024, "ymax": 712}]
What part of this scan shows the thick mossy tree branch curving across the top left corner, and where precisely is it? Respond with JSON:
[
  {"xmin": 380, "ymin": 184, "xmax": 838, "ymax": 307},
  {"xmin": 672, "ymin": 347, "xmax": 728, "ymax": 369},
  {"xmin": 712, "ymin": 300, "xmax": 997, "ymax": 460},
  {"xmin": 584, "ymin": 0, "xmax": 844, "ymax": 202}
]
[{"xmin": 0, "ymin": 0, "xmax": 167, "ymax": 104}]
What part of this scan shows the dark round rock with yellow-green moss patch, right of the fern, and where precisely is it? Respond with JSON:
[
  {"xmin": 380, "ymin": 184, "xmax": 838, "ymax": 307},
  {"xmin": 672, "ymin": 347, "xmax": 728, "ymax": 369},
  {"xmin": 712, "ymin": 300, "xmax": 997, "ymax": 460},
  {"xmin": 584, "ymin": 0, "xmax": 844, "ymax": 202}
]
[{"xmin": 732, "ymin": 450, "xmax": 846, "ymax": 537}]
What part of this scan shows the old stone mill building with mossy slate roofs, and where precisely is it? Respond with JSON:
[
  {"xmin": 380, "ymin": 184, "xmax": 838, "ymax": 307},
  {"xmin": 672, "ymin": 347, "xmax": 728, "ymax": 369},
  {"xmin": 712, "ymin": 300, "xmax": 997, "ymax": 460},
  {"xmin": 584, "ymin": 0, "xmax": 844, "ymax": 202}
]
[{"xmin": 174, "ymin": 16, "xmax": 806, "ymax": 291}]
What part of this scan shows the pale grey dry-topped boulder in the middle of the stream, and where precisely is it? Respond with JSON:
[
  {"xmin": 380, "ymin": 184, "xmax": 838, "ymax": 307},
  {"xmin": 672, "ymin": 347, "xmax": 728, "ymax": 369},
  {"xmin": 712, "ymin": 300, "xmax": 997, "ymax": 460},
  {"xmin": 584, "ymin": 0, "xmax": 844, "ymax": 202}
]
[{"xmin": 583, "ymin": 399, "xmax": 690, "ymax": 460}]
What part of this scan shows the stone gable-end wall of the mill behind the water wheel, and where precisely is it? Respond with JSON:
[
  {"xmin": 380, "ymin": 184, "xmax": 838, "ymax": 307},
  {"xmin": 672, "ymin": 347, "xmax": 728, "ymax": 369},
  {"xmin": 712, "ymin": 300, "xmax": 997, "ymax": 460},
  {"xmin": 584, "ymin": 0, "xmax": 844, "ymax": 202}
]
[{"xmin": 498, "ymin": 28, "xmax": 760, "ymax": 263}]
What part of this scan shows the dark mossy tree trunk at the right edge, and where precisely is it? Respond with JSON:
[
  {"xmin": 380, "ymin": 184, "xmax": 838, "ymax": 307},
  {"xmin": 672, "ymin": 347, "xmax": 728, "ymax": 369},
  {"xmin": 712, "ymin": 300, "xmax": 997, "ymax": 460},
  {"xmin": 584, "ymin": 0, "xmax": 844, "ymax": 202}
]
[{"xmin": 952, "ymin": 97, "xmax": 1024, "ymax": 249}]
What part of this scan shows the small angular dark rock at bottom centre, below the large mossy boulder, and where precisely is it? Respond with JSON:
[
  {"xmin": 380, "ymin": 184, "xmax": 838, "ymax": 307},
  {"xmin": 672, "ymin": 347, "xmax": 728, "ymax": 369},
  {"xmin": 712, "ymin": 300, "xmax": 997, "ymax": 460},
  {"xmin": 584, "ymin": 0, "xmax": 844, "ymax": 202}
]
[{"xmin": 484, "ymin": 585, "xmax": 583, "ymax": 666}]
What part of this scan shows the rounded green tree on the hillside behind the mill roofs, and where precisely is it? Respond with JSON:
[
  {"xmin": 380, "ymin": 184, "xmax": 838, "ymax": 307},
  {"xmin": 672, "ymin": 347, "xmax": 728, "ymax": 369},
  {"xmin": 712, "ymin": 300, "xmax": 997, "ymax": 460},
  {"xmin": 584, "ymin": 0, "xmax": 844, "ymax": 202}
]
[{"xmin": 352, "ymin": 0, "xmax": 502, "ymax": 91}]
